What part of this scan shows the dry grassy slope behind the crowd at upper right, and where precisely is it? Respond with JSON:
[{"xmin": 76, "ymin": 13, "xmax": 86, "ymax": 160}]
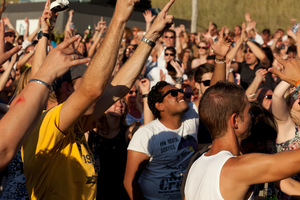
[{"xmin": 152, "ymin": 0, "xmax": 300, "ymax": 33}]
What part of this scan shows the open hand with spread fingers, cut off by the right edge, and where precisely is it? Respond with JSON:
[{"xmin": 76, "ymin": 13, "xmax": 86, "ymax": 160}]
[{"xmin": 268, "ymin": 54, "xmax": 300, "ymax": 85}]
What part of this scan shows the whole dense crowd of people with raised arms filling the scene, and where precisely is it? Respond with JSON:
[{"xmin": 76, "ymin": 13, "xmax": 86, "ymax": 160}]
[{"xmin": 0, "ymin": 0, "xmax": 300, "ymax": 200}]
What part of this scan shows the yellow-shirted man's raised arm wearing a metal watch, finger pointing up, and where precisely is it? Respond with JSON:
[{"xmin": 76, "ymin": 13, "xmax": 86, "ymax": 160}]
[{"xmin": 83, "ymin": 0, "xmax": 175, "ymax": 132}]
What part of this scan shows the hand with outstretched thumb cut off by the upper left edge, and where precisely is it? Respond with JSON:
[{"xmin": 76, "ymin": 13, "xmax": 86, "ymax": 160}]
[{"xmin": 0, "ymin": 20, "xmax": 21, "ymax": 65}]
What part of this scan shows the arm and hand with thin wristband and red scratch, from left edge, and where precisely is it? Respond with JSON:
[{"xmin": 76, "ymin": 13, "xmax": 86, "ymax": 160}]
[{"xmin": 0, "ymin": 35, "xmax": 89, "ymax": 170}]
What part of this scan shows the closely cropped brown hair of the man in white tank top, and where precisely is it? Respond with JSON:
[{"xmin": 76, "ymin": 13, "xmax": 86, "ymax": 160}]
[{"xmin": 199, "ymin": 81, "xmax": 246, "ymax": 140}]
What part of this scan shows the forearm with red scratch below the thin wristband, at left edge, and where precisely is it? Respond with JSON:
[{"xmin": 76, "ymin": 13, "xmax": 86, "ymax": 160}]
[{"xmin": 0, "ymin": 77, "xmax": 49, "ymax": 170}]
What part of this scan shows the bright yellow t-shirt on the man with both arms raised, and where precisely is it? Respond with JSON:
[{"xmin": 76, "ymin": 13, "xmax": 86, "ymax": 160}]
[{"xmin": 22, "ymin": 104, "xmax": 97, "ymax": 200}]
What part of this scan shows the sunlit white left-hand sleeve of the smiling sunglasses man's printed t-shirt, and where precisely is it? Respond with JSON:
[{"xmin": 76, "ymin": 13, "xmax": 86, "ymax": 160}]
[{"xmin": 127, "ymin": 127, "xmax": 152, "ymax": 157}]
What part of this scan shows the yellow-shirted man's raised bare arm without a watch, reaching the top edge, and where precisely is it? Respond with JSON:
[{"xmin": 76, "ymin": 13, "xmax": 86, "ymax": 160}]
[{"xmin": 59, "ymin": 0, "xmax": 143, "ymax": 132}]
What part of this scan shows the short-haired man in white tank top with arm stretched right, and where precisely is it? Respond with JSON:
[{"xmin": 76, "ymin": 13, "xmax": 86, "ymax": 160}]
[{"xmin": 184, "ymin": 81, "xmax": 300, "ymax": 200}]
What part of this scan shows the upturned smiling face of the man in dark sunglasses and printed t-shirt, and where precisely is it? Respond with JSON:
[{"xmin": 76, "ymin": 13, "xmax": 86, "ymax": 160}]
[{"xmin": 161, "ymin": 85, "xmax": 189, "ymax": 116}]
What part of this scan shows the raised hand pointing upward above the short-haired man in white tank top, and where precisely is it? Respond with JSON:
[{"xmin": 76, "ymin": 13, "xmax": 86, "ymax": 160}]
[{"xmin": 212, "ymin": 27, "xmax": 232, "ymax": 57}]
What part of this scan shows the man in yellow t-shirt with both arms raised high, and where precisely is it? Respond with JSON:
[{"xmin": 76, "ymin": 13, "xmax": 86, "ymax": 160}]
[{"xmin": 22, "ymin": 0, "xmax": 174, "ymax": 200}]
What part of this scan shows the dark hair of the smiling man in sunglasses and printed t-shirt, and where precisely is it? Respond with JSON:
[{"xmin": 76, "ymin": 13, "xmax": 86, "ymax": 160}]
[{"xmin": 148, "ymin": 81, "xmax": 170, "ymax": 118}]
